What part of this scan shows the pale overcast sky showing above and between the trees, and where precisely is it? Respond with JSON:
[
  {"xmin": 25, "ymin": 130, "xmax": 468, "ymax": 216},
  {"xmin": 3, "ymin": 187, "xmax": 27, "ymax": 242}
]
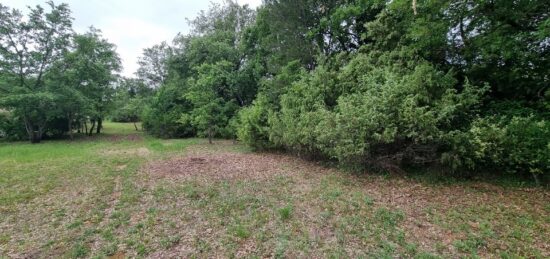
[{"xmin": 2, "ymin": 0, "xmax": 262, "ymax": 77}]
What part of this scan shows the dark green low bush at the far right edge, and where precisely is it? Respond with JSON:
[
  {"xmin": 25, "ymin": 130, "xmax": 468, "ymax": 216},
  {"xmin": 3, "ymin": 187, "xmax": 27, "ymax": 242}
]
[{"xmin": 445, "ymin": 115, "xmax": 550, "ymax": 184}]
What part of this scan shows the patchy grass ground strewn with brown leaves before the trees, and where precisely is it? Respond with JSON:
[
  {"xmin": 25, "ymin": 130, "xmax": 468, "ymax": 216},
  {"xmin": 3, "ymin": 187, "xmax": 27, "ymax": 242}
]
[{"xmin": 0, "ymin": 123, "xmax": 550, "ymax": 258}]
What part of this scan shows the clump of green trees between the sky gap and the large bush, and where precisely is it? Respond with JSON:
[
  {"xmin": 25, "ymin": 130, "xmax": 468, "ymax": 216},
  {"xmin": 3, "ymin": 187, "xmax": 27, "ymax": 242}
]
[{"xmin": 144, "ymin": 2, "xmax": 262, "ymax": 139}]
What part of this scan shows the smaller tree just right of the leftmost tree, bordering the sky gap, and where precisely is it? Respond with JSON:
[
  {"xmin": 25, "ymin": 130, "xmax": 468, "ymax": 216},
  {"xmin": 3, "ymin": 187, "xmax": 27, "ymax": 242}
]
[{"xmin": 51, "ymin": 28, "xmax": 121, "ymax": 135}]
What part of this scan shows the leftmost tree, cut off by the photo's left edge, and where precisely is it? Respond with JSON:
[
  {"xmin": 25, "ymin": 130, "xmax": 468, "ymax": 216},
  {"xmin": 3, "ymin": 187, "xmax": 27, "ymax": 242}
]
[{"xmin": 0, "ymin": 1, "xmax": 72, "ymax": 143}]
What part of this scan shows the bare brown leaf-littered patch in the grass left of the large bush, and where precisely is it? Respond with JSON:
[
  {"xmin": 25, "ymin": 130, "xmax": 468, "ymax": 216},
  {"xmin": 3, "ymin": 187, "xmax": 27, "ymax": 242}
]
[{"xmin": 146, "ymin": 153, "xmax": 298, "ymax": 180}]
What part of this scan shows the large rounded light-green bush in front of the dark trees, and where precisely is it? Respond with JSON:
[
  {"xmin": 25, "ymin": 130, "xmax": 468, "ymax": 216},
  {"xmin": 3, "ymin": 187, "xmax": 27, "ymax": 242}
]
[{"xmin": 268, "ymin": 54, "xmax": 485, "ymax": 171}]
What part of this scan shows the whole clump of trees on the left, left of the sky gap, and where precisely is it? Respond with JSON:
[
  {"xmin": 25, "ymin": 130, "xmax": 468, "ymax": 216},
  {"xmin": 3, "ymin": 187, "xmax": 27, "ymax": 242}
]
[{"xmin": 0, "ymin": 1, "xmax": 120, "ymax": 143}]
